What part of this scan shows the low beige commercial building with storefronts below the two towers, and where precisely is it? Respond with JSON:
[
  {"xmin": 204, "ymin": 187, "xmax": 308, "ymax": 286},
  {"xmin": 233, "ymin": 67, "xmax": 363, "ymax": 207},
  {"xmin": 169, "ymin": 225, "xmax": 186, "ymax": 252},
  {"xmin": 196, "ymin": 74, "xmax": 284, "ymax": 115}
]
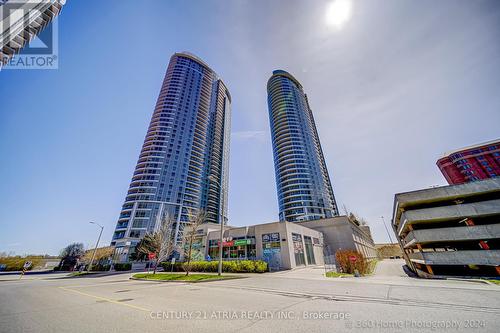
[{"xmin": 185, "ymin": 216, "xmax": 376, "ymax": 271}]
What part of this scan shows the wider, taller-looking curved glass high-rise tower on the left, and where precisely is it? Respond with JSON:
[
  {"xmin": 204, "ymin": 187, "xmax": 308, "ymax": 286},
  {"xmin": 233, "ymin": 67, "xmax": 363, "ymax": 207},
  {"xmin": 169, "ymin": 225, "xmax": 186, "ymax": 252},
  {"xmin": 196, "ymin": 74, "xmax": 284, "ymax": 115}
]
[{"xmin": 111, "ymin": 53, "xmax": 231, "ymax": 260}]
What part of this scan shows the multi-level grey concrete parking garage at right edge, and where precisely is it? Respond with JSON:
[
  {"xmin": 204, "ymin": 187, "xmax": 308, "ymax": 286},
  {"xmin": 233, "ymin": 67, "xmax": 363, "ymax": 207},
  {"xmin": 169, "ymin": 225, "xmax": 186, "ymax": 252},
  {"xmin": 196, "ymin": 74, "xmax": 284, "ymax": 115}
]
[{"xmin": 392, "ymin": 178, "xmax": 500, "ymax": 277}]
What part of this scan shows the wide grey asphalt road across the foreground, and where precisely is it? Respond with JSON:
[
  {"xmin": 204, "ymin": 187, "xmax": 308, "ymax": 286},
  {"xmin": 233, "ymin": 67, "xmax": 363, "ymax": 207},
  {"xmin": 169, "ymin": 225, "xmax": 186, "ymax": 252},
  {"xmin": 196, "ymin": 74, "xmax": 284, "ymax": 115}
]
[{"xmin": 0, "ymin": 262, "xmax": 500, "ymax": 333}]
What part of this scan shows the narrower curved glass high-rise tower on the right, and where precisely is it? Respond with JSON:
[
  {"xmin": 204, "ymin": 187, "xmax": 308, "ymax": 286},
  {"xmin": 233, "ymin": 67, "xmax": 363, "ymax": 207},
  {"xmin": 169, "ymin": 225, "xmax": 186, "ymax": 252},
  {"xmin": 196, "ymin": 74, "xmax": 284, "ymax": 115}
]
[{"xmin": 267, "ymin": 70, "xmax": 338, "ymax": 222}]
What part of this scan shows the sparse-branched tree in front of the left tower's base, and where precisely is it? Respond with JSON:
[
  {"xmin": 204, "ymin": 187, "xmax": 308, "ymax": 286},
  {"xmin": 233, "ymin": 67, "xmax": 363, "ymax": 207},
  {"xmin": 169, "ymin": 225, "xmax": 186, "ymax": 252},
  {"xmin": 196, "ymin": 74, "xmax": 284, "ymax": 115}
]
[{"xmin": 136, "ymin": 215, "xmax": 175, "ymax": 274}]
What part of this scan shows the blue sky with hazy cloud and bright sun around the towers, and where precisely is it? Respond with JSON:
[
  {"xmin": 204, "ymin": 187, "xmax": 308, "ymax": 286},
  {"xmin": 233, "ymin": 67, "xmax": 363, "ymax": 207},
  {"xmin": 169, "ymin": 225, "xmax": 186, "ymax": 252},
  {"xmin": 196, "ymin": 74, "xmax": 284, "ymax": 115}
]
[{"xmin": 0, "ymin": 0, "xmax": 500, "ymax": 254}]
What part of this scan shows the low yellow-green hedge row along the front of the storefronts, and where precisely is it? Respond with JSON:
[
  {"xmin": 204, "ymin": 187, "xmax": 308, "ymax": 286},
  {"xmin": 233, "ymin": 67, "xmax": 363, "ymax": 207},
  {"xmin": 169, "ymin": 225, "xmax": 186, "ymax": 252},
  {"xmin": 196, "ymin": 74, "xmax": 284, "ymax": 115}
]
[{"xmin": 161, "ymin": 260, "xmax": 267, "ymax": 273}]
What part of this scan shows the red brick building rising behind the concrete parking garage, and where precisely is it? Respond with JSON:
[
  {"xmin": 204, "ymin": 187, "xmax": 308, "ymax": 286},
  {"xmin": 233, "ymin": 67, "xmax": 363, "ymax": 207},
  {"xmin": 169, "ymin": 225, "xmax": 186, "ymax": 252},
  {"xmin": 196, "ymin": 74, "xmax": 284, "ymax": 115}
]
[{"xmin": 436, "ymin": 140, "xmax": 500, "ymax": 185}]
